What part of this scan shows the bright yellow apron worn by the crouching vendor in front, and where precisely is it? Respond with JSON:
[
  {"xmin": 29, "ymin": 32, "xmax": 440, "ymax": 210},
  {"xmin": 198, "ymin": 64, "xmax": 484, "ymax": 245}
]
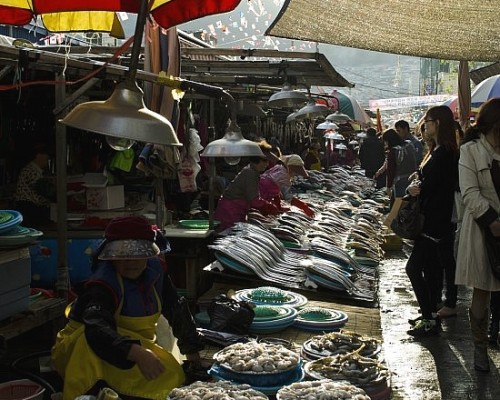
[{"xmin": 52, "ymin": 276, "xmax": 185, "ymax": 400}]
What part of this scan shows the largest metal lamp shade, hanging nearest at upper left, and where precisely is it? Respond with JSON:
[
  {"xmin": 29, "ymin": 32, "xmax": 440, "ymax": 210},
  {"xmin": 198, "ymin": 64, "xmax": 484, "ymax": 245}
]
[{"xmin": 60, "ymin": 80, "xmax": 182, "ymax": 146}]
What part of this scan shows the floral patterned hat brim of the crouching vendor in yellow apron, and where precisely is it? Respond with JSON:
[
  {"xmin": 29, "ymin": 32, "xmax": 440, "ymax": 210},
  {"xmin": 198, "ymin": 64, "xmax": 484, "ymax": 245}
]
[{"xmin": 98, "ymin": 239, "xmax": 160, "ymax": 260}]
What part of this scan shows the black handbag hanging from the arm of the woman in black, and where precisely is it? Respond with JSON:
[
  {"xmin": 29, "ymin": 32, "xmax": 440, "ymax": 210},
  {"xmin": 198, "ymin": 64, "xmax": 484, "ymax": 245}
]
[{"xmin": 391, "ymin": 195, "xmax": 425, "ymax": 240}]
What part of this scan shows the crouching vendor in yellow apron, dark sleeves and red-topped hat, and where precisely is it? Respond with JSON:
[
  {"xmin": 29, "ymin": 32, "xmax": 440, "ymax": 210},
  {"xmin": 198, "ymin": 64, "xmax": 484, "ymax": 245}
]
[{"xmin": 52, "ymin": 217, "xmax": 203, "ymax": 400}]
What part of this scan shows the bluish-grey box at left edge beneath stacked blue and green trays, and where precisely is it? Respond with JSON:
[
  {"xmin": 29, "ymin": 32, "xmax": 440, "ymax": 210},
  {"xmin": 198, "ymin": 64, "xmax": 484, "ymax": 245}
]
[{"xmin": 0, "ymin": 247, "xmax": 31, "ymax": 320}]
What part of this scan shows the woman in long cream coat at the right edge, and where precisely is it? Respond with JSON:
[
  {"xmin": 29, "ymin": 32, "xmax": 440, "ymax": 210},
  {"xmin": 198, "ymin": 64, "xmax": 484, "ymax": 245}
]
[{"xmin": 455, "ymin": 98, "xmax": 500, "ymax": 372}]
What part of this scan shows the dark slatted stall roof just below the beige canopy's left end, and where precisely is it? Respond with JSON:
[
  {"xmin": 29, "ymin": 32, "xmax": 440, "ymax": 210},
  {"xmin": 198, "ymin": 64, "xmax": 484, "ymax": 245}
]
[{"xmin": 181, "ymin": 47, "xmax": 354, "ymax": 100}]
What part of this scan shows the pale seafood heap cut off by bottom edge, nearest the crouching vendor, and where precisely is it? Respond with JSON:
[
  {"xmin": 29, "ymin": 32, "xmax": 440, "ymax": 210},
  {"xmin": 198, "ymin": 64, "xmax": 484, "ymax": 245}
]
[{"xmin": 167, "ymin": 381, "xmax": 268, "ymax": 400}]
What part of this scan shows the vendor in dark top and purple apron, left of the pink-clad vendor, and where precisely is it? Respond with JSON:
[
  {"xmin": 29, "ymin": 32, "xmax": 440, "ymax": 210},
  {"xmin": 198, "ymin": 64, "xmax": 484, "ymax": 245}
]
[{"xmin": 214, "ymin": 145, "xmax": 279, "ymax": 231}]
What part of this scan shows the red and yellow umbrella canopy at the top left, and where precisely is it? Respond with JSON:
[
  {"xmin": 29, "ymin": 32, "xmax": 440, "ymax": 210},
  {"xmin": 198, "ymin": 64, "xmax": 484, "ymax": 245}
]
[{"xmin": 0, "ymin": 0, "xmax": 241, "ymax": 32}]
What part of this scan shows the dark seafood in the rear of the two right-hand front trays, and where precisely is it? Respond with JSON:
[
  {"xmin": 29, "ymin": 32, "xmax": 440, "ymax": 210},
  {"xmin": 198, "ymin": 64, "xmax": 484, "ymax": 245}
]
[{"xmin": 302, "ymin": 330, "xmax": 381, "ymax": 360}]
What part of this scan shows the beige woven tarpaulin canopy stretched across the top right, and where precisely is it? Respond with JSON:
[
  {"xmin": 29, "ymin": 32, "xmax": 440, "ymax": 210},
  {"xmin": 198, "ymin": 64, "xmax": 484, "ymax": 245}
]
[{"xmin": 265, "ymin": 0, "xmax": 500, "ymax": 61}]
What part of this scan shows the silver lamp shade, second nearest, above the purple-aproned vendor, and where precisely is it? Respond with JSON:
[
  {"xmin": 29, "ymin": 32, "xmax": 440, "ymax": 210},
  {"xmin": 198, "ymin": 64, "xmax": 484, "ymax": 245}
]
[{"xmin": 201, "ymin": 124, "xmax": 265, "ymax": 158}]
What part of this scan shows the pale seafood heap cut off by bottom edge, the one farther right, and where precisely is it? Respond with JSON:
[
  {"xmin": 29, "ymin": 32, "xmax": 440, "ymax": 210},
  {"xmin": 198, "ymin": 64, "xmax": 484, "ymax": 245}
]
[{"xmin": 276, "ymin": 379, "xmax": 370, "ymax": 400}]
